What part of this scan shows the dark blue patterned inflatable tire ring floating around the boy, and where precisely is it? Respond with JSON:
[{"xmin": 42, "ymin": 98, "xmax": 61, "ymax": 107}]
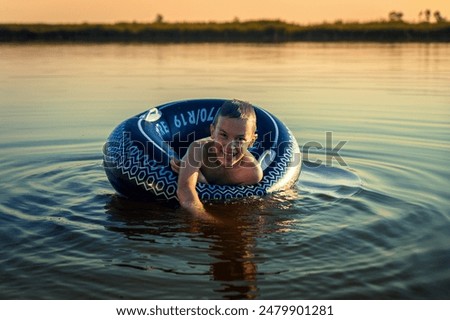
[{"xmin": 103, "ymin": 99, "xmax": 302, "ymax": 200}]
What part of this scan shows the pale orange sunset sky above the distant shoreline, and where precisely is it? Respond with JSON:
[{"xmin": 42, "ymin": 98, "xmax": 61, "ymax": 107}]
[{"xmin": 0, "ymin": 0, "xmax": 450, "ymax": 24}]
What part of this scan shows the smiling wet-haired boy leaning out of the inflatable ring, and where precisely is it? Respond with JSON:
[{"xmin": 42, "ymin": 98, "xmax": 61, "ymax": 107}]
[{"xmin": 171, "ymin": 100, "xmax": 263, "ymax": 219}]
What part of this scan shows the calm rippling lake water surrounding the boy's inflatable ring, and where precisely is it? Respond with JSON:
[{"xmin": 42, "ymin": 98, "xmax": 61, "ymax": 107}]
[{"xmin": 0, "ymin": 43, "xmax": 450, "ymax": 299}]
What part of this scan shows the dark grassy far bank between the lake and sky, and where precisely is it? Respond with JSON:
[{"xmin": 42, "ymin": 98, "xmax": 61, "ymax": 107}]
[{"xmin": 0, "ymin": 20, "xmax": 450, "ymax": 43}]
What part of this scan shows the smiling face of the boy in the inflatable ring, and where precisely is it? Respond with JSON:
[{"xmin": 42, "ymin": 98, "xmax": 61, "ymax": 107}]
[{"xmin": 211, "ymin": 116, "xmax": 256, "ymax": 167}]
